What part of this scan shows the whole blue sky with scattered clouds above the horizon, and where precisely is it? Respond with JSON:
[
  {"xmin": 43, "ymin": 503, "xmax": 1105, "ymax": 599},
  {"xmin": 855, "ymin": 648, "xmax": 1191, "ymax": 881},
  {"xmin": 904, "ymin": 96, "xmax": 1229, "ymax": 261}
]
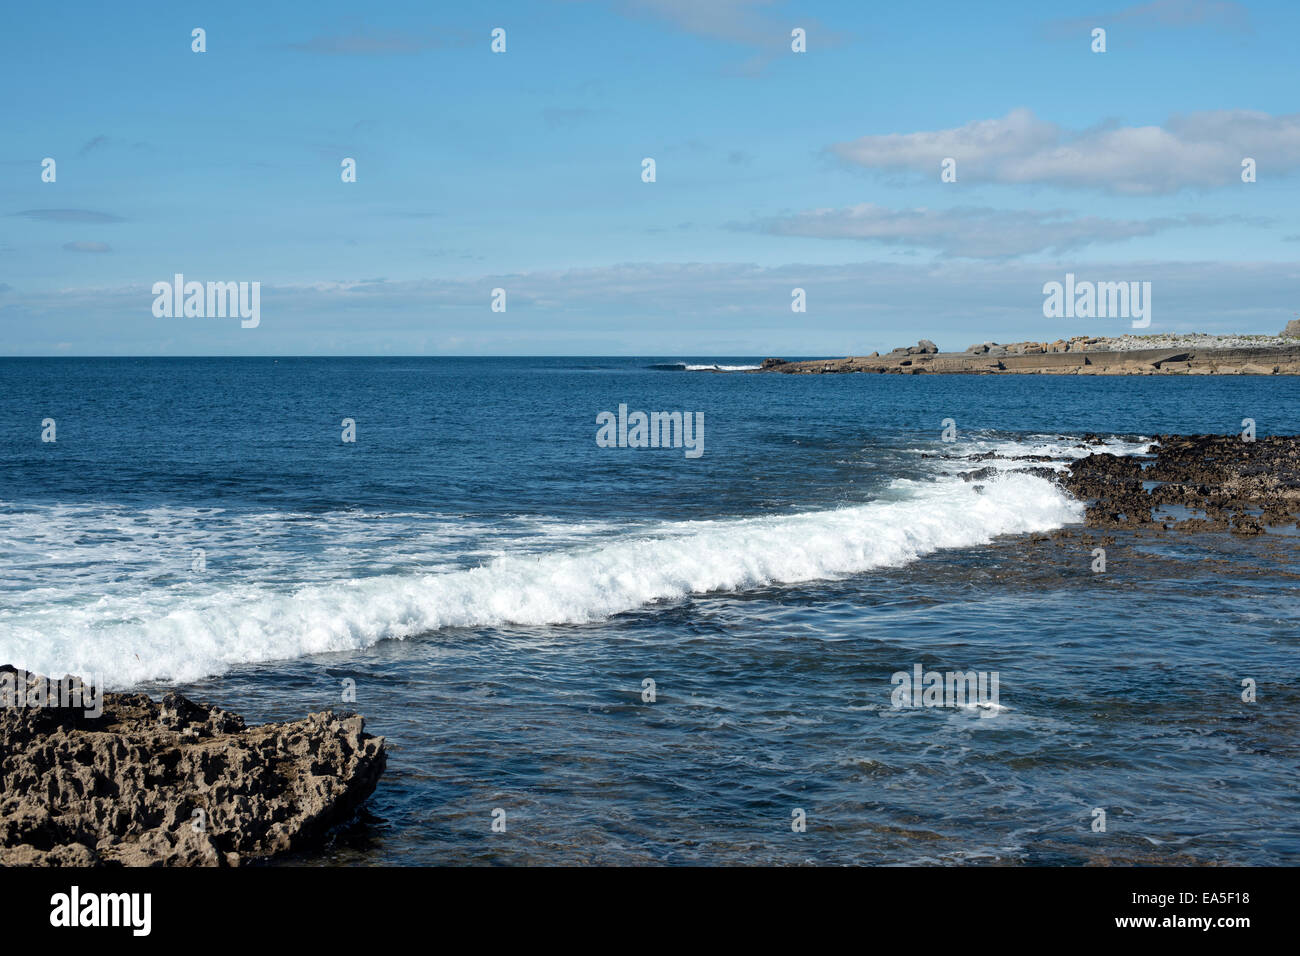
[{"xmin": 0, "ymin": 0, "xmax": 1300, "ymax": 359}]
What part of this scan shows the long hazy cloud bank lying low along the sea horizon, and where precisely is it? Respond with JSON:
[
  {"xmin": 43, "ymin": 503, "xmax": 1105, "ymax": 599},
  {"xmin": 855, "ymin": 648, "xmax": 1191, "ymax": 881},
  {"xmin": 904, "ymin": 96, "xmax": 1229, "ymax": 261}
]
[{"xmin": 10, "ymin": 259, "xmax": 1300, "ymax": 358}]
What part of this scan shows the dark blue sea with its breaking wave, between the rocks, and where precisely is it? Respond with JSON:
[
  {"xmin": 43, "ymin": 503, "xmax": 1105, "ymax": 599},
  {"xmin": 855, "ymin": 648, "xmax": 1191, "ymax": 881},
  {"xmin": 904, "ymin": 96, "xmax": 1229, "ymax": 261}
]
[{"xmin": 0, "ymin": 356, "xmax": 1300, "ymax": 864}]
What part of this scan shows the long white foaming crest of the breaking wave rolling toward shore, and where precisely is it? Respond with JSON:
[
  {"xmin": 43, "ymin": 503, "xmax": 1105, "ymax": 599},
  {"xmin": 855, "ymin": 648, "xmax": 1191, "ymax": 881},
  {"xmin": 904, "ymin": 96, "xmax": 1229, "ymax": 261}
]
[{"xmin": 0, "ymin": 473, "xmax": 1083, "ymax": 687}]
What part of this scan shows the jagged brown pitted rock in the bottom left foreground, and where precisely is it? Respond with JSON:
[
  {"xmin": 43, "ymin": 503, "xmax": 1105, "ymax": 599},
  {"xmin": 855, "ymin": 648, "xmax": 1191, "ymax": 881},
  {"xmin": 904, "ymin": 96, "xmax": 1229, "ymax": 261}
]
[{"xmin": 0, "ymin": 667, "xmax": 386, "ymax": 866}]
